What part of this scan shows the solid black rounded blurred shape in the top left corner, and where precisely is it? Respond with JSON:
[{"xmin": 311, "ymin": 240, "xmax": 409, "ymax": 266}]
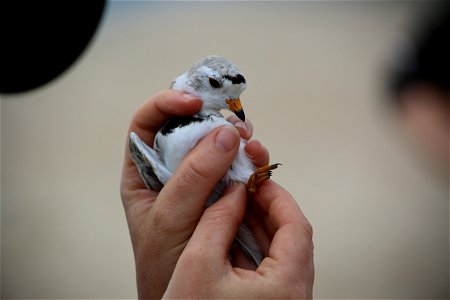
[{"xmin": 0, "ymin": 0, "xmax": 105, "ymax": 93}]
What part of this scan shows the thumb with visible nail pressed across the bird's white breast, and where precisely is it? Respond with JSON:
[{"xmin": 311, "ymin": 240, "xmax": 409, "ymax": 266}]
[{"xmin": 154, "ymin": 126, "xmax": 240, "ymax": 228}]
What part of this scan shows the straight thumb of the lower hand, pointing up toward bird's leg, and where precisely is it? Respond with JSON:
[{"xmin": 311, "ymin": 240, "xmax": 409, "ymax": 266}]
[{"xmin": 185, "ymin": 183, "xmax": 246, "ymax": 266}]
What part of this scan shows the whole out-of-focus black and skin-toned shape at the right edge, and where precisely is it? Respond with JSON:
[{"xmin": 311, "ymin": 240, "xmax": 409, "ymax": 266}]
[{"xmin": 390, "ymin": 1, "xmax": 450, "ymax": 169}]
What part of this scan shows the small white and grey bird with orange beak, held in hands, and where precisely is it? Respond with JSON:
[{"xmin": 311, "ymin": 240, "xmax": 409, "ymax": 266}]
[{"xmin": 129, "ymin": 55, "xmax": 280, "ymax": 266}]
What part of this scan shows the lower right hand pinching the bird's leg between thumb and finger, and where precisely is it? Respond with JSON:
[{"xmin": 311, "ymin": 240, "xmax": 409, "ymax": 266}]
[{"xmin": 163, "ymin": 180, "xmax": 314, "ymax": 299}]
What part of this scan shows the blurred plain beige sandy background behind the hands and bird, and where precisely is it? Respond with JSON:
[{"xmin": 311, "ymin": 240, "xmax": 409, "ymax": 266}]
[{"xmin": 1, "ymin": 2, "xmax": 449, "ymax": 299}]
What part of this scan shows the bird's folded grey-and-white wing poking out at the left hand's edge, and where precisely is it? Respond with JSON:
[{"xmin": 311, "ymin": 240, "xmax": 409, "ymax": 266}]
[{"xmin": 129, "ymin": 132, "xmax": 172, "ymax": 191}]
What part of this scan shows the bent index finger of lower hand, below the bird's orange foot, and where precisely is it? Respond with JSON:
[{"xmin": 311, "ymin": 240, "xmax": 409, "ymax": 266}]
[{"xmin": 255, "ymin": 180, "xmax": 312, "ymax": 266}]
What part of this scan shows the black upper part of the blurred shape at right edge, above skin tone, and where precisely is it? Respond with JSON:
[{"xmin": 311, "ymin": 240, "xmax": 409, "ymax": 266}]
[{"xmin": 390, "ymin": 1, "xmax": 450, "ymax": 100}]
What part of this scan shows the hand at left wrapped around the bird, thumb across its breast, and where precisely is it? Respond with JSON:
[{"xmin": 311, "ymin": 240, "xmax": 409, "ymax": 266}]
[{"xmin": 120, "ymin": 90, "xmax": 269, "ymax": 299}]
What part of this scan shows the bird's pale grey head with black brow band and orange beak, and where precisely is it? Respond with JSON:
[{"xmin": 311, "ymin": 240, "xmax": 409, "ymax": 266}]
[{"xmin": 175, "ymin": 55, "xmax": 246, "ymax": 121}]
